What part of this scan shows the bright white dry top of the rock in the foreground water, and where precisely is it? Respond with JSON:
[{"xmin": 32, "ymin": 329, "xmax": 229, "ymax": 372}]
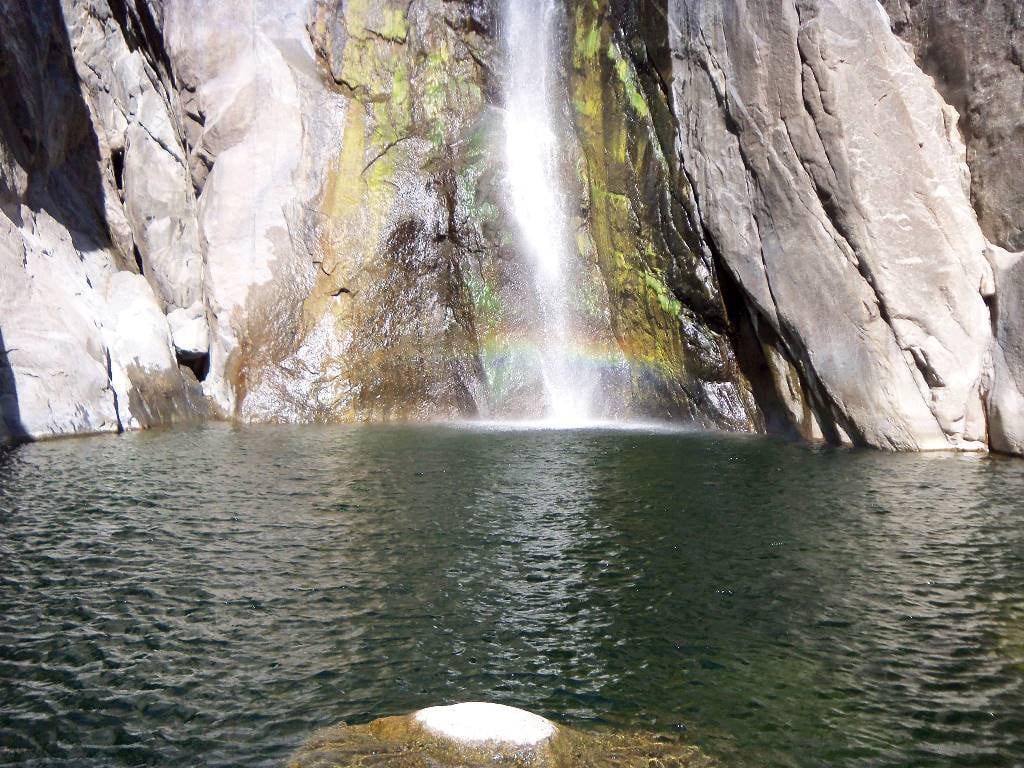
[{"xmin": 415, "ymin": 701, "xmax": 555, "ymax": 746}]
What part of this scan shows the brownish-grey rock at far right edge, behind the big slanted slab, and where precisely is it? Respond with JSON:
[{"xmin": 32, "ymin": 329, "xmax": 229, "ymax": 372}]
[{"xmin": 885, "ymin": 0, "xmax": 1024, "ymax": 454}]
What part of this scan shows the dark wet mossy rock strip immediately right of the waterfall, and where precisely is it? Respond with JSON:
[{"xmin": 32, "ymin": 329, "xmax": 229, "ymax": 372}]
[{"xmin": 569, "ymin": 0, "xmax": 757, "ymax": 429}]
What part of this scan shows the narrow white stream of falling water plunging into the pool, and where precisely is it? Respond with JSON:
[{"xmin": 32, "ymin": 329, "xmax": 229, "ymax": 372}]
[{"xmin": 505, "ymin": 0, "xmax": 594, "ymax": 425}]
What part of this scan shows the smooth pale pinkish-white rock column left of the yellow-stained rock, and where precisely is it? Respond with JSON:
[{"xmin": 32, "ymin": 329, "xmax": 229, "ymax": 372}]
[{"xmin": 164, "ymin": 0, "xmax": 335, "ymax": 418}]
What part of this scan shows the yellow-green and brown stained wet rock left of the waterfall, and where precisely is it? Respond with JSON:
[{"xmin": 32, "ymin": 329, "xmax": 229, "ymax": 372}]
[{"xmin": 304, "ymin": 0, "xmax": 497, "ymax": 420}]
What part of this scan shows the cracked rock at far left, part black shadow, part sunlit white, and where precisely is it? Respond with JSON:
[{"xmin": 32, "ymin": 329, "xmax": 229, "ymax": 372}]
[{"xmin": 0, "ymin": 0, "xmax": 206, "ymax": 439}]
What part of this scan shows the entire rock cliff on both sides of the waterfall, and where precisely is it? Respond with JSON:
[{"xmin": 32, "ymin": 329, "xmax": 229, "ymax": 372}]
[{"xmin": 0, "ymin": 0, "xmax": 1024, "ymax": 453}]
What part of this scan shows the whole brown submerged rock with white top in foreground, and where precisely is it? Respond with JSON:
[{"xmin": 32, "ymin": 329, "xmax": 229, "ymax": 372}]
[{"xmin": 288, "ymin": 702, "xmax": 716, "ymax": 768}]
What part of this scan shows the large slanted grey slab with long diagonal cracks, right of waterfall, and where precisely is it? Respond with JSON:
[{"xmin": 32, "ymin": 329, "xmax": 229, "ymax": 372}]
[{"xmin": 670, "ymin": 0, "xmax": 994, "ymax": 450}]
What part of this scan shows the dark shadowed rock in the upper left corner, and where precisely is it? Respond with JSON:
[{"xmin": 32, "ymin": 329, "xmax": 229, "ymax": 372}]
[{"xmin": 0, "ymin": 0, "xmax": 111, "ymax": 250}]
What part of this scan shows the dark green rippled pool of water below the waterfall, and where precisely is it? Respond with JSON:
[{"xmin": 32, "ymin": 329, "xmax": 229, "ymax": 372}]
[{"xmin": 0, "ymin": 427, "xmax": 1024, "ymax": 767}]
